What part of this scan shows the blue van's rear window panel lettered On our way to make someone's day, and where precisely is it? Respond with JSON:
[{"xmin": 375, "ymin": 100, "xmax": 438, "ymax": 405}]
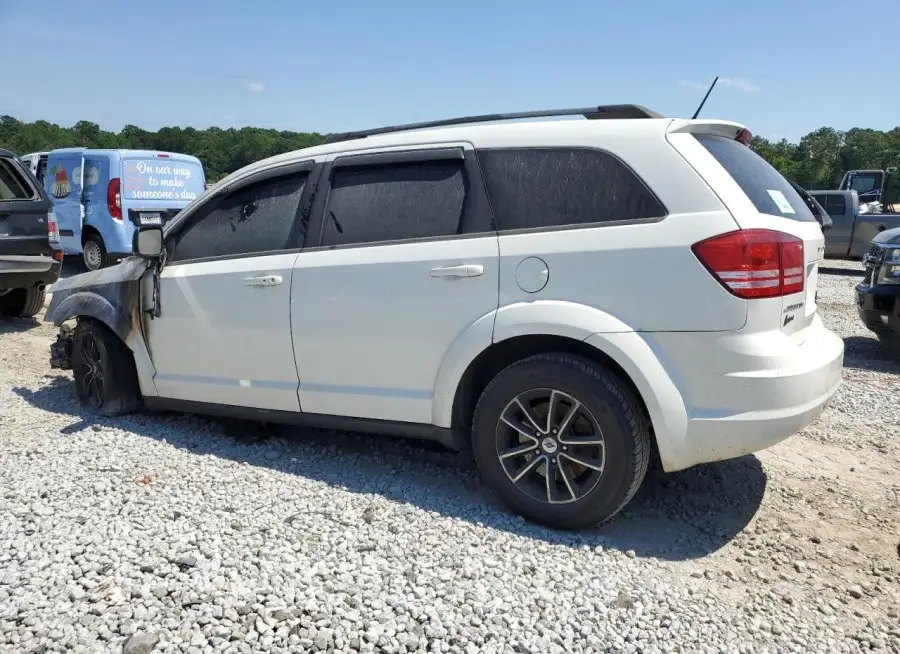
[{"xmin": 122, "ymin": 159, "xmax": 204, "ymax": 202}]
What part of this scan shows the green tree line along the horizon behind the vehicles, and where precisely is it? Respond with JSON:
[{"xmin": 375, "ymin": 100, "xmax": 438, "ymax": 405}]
[{"xmin": 0, "ymin": 116, "xmax": 900, "ymax": 189}]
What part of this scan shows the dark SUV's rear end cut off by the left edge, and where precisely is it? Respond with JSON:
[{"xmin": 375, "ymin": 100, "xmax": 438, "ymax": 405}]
[{"xmin": 0, "ymin": 150, "xmax": 62, "ymax": 317}]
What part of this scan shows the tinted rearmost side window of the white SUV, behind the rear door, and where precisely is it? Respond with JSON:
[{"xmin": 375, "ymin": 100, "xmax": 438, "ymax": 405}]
[{"xmin": 478, "ymin": 148, "xmax": 666, "ymax": 231}]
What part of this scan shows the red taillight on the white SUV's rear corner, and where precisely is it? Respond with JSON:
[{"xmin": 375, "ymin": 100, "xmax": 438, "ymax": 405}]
[{"xmin": 691, "ymin": 229, "xmax": 805, "ymax": 300}]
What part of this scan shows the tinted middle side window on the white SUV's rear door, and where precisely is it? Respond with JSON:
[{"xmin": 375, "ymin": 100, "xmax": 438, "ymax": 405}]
[{"xmin": 322, "ymin": 159, "xmax": 466, "ymax": 246}]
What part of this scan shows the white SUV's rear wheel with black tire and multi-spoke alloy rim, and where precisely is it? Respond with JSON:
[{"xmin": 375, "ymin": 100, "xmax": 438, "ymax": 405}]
[{"xmin": 472, "ymin": 354, "xmax": 652, "ymax": 529}]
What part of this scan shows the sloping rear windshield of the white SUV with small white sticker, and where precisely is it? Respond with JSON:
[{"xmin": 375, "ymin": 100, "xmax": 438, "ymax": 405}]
[{"xmin": 695, "ymin": 134, "xmax": 816, "ymax": 221}]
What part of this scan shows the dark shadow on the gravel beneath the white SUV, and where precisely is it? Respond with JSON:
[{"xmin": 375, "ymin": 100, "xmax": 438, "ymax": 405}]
[{"xmin": 12, "ymin": 376, "xmax": 766, "ymax": 561}]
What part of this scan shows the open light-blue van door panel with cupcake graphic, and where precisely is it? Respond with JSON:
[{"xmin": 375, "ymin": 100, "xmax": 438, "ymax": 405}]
[{"xmin": 44, "ymin": 148, "xmax": 84, "ymax": 254}]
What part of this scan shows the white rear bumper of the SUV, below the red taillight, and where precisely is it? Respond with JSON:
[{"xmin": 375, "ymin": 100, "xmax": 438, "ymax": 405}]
[{"xmin": 647, "ymin": 316, "xmax": 844, "ymax": 471}]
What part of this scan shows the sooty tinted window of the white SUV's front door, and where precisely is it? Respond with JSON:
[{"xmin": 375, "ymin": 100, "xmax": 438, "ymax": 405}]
[{"xmin": 170, "ymin": 172, "xmax": 307, "ymax": 261}]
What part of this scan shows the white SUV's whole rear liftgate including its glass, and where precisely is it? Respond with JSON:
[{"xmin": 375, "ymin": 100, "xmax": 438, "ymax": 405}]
[{"xmin": 669, "ymin": 121, "xmax": 825, "ymax": 334}]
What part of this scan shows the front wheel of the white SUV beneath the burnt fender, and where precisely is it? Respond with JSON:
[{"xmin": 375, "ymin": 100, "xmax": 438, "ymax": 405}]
[{"xmin": 72, "ymin": 318, "xmax": 142, "ymax": 417}]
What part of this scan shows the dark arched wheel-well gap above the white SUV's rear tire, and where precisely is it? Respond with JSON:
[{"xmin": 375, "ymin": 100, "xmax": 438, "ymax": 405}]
[{"xmin": 452, "ymin": 334, "xmax": 659, "ymax": 460}]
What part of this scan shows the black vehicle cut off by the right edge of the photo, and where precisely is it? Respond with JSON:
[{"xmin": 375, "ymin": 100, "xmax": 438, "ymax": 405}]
[{"xmin": 856, "ymin": 241, "xmax": 900, "ymax": 338}]
